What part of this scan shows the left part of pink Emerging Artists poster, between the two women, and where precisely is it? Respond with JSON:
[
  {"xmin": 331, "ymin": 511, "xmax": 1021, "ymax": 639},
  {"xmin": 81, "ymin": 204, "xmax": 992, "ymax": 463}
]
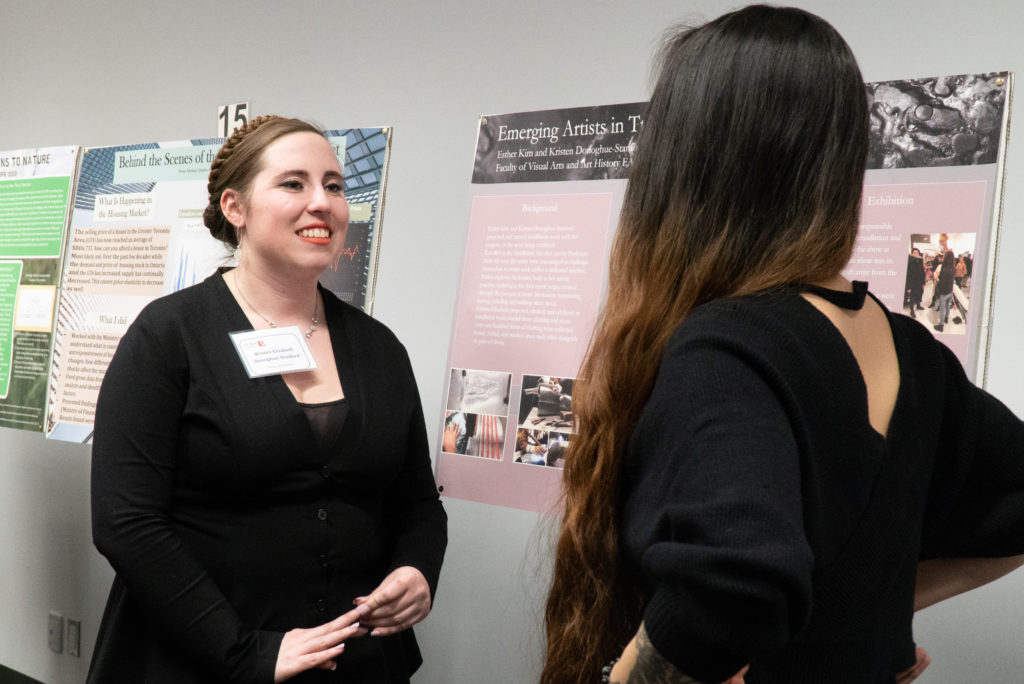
[{"xmin": 437, "ymin": 103, "xmax": 644, "ymax": 511}]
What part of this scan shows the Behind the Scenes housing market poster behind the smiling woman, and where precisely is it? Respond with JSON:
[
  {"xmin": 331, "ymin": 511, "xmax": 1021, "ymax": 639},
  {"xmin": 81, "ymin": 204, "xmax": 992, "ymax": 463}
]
[{"xmin": 46, "ymin": 129, "xmax": 390, "ymax": 442}]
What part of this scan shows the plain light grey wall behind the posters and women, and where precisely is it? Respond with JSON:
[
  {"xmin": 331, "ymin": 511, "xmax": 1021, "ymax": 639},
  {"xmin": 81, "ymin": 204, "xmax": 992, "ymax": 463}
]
[{"xmin": 0, "ymin": 0, "xmax": 1024, "ymax": 684}]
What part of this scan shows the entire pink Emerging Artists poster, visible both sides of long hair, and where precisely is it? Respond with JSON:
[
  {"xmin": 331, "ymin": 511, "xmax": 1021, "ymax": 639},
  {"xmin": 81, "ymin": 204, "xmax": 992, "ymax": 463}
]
[{"xmin": 435, "ymin": 73, "xmax": 1011, "ymax": 512}]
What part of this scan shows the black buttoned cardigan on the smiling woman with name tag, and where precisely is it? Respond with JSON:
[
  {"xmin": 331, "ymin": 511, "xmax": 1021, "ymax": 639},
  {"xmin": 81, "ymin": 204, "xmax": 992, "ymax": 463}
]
[{"xmin": 88, "ymin": 274, "xmax": 446, "ymax": 684}]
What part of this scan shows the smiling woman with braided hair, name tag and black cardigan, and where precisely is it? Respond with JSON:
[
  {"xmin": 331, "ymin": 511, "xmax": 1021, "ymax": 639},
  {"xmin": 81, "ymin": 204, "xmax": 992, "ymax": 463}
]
[{"xmin": 88, "ymin": 117, "xmax": 446, "ymax": 684}]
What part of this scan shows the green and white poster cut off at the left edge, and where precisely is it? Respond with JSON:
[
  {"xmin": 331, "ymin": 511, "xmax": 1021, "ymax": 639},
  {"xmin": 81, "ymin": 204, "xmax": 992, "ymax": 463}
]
[{"xmin": 0, "ymin": 146, "xmax": 79, "ymax": 432}]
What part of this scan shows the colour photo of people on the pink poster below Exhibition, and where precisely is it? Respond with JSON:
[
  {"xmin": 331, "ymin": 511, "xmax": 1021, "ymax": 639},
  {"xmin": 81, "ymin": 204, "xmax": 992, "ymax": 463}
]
[{"xmin": 903, "ymin": 232, "xmax": 977, "ymax": 335}]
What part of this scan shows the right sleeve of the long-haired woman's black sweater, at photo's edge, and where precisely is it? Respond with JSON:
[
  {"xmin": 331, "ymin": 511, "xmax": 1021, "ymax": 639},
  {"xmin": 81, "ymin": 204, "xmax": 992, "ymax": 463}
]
[{"xmin": 922, "ymin": 347, "xmax": 1024, "ymax": 559}]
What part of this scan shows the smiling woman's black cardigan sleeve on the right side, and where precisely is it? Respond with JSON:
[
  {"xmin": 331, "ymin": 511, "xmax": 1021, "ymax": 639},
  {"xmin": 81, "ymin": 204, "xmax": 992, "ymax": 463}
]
[{"xmin": 385, "ymin": 349, "xmax": 447, "ymax": 600}]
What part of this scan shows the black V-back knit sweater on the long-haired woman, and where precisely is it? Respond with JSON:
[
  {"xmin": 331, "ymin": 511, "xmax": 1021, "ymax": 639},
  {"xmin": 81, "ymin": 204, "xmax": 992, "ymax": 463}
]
[{"xmin": 620, "ymin": 288, "xmax": 1024, "ymax": 684}]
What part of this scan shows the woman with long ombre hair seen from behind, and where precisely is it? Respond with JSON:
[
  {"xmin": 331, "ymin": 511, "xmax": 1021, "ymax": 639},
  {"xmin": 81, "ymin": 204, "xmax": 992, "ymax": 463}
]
[{"xmin": 542, "ymin": 6, "xmax": 1024, "ymax": 684}]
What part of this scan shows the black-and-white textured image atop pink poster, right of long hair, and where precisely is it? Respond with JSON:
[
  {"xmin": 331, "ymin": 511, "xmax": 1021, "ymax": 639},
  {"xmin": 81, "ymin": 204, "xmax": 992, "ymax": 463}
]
[{"xmin": 867, "ymin": 72, "xmax": 1007, "ymax": 169}]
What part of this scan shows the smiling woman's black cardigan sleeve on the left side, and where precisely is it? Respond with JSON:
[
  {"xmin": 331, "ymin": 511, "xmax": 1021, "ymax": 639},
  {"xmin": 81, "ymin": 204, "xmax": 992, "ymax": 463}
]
[{"xmin": 92, "ymin": 311, "xmax": 284, "ymax": 683}]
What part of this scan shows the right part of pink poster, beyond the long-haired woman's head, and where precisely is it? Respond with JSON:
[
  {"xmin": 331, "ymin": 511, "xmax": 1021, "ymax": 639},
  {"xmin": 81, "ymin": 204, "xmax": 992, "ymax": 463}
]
[{"xmin": 845, "ymin": 72, "xmax": 1013, "ymax": 384}]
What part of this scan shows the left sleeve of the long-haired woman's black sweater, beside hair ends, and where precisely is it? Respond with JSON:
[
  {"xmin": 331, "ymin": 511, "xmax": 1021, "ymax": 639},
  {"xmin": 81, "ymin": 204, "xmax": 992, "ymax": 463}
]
[{"xmin": 627, "ymin": 333, "xmax": 814, "ymax": 682}]
